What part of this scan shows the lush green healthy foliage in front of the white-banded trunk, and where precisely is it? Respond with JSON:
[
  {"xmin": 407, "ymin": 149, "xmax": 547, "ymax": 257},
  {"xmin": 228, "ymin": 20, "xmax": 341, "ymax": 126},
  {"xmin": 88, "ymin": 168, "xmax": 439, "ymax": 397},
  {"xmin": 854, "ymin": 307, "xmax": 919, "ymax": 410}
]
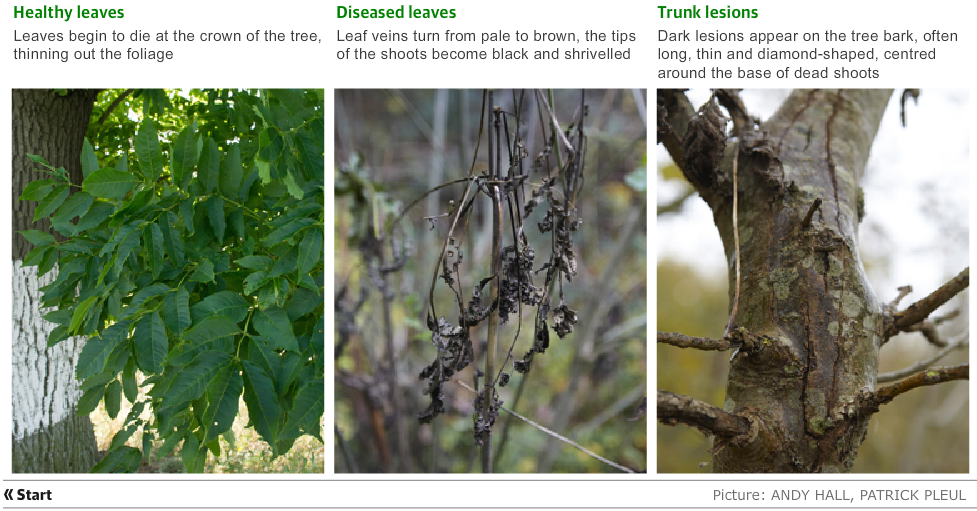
[{"xmin": 21, "ymin": 91, "xmax": 325, "ymax": 472}]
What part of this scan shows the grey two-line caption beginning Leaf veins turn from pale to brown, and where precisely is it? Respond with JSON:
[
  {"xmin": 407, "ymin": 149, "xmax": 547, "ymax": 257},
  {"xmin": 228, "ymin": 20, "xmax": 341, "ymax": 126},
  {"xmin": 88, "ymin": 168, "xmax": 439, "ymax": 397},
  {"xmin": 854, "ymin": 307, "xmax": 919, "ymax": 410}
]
[{"xmin": 336, "ymin": 29, "xmax": 637, "ymax": 61}]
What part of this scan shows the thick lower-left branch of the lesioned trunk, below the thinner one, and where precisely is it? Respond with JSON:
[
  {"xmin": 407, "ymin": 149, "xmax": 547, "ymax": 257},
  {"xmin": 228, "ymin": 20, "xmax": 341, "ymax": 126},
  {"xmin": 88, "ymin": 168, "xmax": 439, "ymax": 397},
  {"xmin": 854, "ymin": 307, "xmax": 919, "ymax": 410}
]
[{"xmin": 658, "ymin": 390, "xmax": 751, "ymax": 439}]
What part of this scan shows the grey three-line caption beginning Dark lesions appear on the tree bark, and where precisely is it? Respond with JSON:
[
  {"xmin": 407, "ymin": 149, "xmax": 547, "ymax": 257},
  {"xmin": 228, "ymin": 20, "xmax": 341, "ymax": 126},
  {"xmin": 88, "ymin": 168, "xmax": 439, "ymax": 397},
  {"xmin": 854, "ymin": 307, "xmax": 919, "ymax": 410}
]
[{"xmin": 657, "ymin": 29, "xmax": 959, "ymax": 80}]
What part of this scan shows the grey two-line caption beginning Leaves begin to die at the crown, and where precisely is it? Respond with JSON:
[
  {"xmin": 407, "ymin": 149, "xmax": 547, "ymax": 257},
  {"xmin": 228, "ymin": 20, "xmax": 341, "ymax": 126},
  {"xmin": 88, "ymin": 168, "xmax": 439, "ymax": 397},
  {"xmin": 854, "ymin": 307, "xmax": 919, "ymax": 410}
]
[{"xmin": 13, "ymin": 29, "xmax": 322, "ymax": 62}]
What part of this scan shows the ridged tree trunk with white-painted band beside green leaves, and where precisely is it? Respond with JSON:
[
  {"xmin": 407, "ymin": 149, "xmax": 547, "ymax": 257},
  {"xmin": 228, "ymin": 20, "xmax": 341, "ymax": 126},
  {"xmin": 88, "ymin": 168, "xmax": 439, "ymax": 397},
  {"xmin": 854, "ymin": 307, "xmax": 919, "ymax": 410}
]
[{"xmin": 11, "ymin": 89, "xmax": 98, "ymax": 473}]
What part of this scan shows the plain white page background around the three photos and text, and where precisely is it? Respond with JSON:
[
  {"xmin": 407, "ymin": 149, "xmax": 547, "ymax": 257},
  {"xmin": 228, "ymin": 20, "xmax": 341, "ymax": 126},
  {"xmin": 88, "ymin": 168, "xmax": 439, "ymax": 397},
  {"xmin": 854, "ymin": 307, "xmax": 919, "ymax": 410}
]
[{"xmin": 0, "ymin": 0, "xmax": 977, "ymax": 508}]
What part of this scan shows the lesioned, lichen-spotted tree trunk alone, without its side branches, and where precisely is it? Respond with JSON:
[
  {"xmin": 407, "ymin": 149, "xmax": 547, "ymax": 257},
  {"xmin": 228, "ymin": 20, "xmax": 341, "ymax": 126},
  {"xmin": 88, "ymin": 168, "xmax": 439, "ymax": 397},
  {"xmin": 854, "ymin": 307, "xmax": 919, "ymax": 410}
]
[{"xmin": 684, "ymin": 90, "xmax": 891, "ymax": 472}]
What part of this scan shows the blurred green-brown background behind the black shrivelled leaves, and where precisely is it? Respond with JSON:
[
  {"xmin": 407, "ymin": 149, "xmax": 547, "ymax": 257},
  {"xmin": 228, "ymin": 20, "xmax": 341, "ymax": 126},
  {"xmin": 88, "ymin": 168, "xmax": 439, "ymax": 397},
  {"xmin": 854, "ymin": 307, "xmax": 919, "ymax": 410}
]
[{"xmin": 334, "ymin": 89, "xmax": 648, "ymax": 473}]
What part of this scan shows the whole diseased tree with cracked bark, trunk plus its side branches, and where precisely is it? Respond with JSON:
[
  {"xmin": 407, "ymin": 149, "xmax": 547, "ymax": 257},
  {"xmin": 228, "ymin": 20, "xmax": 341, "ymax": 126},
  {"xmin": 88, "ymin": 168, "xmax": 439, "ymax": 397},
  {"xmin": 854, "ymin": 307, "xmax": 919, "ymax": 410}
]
[{"xmin": 658, "ymin": 90, "xmax": 969, "ymax": 472}]
